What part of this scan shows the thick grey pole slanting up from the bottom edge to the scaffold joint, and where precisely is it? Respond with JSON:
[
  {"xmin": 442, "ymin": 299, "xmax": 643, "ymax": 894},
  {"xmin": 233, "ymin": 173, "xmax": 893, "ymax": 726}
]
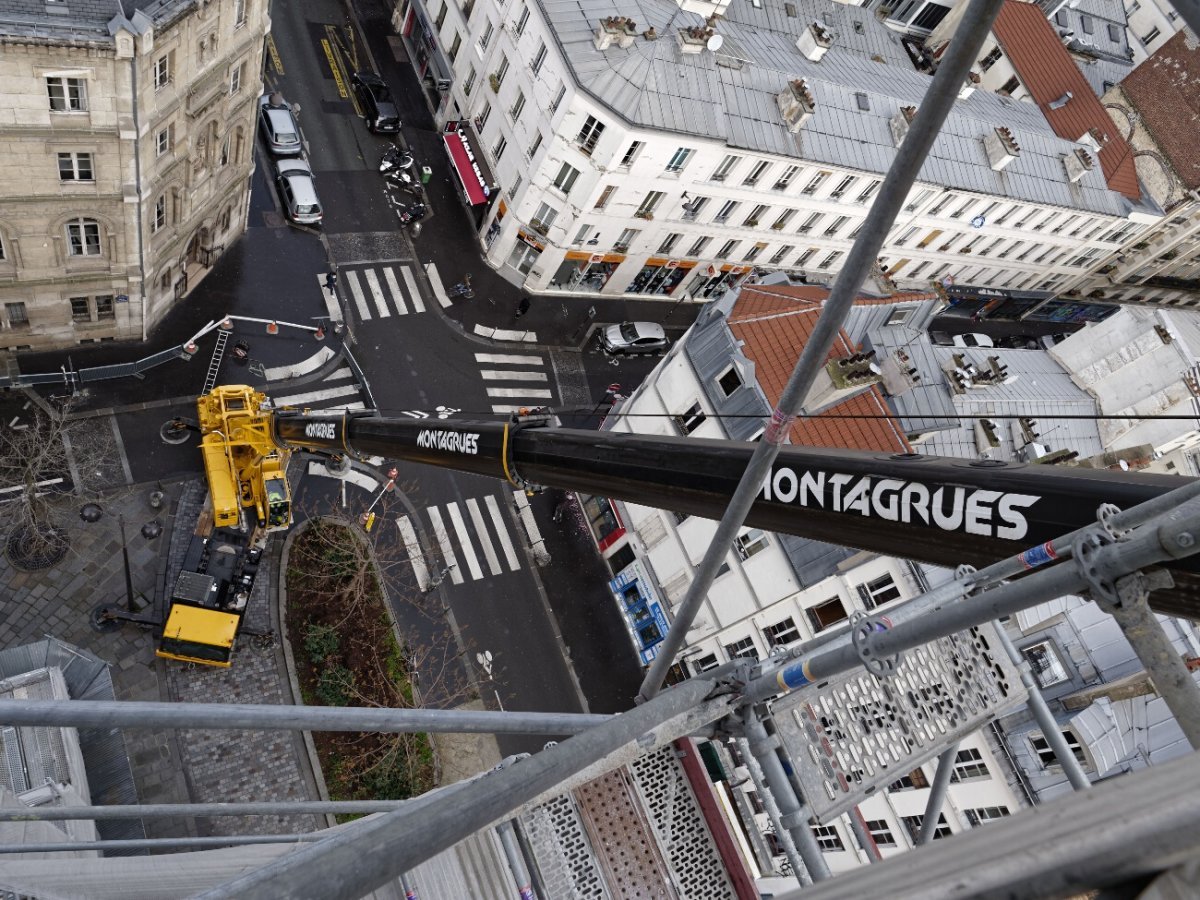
[{"xmin": 199, "ymin": 677, "xmax": 733, "ymax": 900}]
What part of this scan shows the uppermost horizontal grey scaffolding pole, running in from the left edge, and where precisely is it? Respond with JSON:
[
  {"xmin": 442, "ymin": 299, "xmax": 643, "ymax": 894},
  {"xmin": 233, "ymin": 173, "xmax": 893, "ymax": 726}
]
[{"xmin": 0, "ymin": 700, "xmax": 613, "ymax": 736}]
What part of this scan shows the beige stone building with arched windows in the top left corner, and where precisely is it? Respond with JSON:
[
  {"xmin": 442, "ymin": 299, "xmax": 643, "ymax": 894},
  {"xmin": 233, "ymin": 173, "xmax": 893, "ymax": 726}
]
[{"xmin": 0, "ymin": 0, "xmax": 269, "ymax": 352}]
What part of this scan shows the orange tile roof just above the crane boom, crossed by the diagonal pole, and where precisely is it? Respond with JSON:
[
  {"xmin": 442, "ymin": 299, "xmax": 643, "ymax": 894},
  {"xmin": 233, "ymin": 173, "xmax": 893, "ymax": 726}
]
[{"xmin": 728, "ymin": 286, "xmax": 912, "ymax": 452}]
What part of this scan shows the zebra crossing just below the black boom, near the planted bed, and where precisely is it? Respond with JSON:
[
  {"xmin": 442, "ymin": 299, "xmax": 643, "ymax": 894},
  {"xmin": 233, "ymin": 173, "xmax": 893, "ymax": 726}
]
[{"xmin": 396, "ymin": 494, "xmax": 521, "ymax": 590}]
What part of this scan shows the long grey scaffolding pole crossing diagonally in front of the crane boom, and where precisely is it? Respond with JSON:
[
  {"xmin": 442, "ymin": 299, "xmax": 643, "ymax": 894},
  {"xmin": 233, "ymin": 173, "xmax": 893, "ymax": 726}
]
[{"xmin": 637, "ymin": 0, "xmax": 1003, "ymax": 701}]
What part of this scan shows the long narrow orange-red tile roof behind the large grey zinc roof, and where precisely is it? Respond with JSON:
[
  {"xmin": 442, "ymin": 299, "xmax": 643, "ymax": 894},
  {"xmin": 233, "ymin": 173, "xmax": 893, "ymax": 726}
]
[{"xmin": 992, "ymin": 0, "xmax": 1141, "ymax": 200}]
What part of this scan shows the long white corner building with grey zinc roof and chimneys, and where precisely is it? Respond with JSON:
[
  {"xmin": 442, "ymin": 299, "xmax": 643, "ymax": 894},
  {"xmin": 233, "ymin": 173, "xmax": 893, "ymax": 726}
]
[{"xmin": 398, "ymin": 0, "xmax": 1150, "ymax": 307}]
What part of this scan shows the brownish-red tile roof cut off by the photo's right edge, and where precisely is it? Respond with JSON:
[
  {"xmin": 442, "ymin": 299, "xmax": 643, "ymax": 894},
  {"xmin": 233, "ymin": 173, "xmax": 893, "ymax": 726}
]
[{"xmin": 1121, "ymin": 29, "xmax": 1200, "ymax": 191}]
